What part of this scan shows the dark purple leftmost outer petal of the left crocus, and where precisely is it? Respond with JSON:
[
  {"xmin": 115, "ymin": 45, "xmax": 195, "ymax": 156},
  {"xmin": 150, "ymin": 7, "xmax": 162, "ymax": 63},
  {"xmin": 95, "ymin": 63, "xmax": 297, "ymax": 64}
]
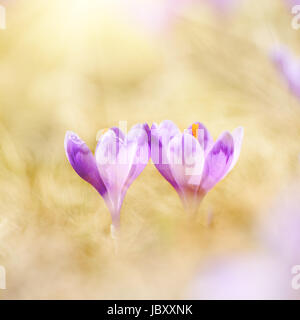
[{"xmin": 64, "ymin": 131, "xmax": 106, "ymax": 196}]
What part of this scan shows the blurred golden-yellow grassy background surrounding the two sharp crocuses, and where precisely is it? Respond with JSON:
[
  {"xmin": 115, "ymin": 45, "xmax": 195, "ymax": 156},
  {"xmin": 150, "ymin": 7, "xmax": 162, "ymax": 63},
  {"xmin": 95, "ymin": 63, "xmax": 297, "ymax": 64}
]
[{"xmin": 0, "ymin": 0, "xmax": 300, "ymax": 299}]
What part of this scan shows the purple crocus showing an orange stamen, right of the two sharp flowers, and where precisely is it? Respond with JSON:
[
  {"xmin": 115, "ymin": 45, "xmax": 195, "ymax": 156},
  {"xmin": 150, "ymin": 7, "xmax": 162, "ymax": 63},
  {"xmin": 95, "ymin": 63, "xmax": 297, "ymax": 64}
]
[{"xmin": 151, "ymin": 120, "xmax": 243, "ymax": 212}]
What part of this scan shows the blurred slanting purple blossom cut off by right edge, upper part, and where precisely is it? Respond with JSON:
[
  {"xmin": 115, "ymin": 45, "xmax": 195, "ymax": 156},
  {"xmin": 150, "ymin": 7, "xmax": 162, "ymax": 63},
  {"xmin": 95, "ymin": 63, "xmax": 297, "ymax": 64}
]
[{"xmin": 271, "ymin": 46, "xmax": 300, "ymax": 99}]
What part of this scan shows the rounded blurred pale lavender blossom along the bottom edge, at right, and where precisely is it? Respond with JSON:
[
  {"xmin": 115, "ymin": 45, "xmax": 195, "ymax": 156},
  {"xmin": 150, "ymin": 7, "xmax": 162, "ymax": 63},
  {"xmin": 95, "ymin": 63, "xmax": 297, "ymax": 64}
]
[{"xmin": 187, "ymin": 252, "xmax": 292, "ymax": 300}]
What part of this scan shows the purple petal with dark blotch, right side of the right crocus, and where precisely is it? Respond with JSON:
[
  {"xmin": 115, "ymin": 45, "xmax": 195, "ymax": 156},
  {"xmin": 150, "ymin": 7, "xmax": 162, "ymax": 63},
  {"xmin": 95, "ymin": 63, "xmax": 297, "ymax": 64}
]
[{"xmin": 200, "ymin": 132, "xmax": 234, "ymax": 192}]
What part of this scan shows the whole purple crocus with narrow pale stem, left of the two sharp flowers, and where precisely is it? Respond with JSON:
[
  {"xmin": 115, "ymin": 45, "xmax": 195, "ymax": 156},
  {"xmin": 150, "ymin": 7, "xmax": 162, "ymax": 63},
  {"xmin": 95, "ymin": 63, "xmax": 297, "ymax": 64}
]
[{"xmin": 65, "ymin": 124, "xmax": 150, "ymax": 232}]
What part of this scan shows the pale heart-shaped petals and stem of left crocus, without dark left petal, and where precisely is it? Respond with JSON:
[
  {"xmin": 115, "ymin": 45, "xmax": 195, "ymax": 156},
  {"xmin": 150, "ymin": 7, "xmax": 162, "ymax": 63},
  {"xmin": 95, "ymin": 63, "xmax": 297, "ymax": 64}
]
[{"xmin": 95, "ymin": 124, "xmax": 150, "ymax": 227}]
